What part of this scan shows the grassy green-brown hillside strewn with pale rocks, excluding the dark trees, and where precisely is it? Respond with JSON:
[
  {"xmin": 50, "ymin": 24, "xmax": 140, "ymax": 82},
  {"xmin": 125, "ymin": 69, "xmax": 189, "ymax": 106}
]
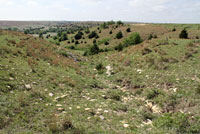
[{"xmin": 0, "ymin": 24, "xmax": 200, "ymax": 134}]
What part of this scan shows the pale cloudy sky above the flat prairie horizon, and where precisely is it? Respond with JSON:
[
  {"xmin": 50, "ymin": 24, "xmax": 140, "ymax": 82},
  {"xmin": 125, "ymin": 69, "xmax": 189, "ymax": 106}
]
[{"xmin": 0, "ymin": 0, "xmax": 200, "ymax": 23}]
